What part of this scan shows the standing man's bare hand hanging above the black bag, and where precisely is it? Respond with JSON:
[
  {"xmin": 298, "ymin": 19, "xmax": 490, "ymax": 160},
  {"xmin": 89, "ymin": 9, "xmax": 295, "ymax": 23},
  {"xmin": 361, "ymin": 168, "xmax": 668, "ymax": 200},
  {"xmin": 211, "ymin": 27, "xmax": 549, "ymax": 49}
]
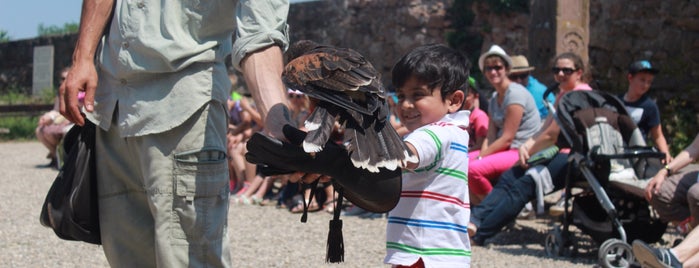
[{"xmin": 58, "ymin": 62, "xmax": 98, "ymax": 126}]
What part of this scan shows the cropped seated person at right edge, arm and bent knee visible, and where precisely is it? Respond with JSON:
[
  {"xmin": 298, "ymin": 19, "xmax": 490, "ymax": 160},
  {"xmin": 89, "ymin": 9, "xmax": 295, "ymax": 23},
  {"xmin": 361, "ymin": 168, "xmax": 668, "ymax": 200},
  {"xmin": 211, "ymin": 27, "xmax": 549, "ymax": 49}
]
[{"xmin": 646, "ymin": 134, "xmax": 699, "ymax": 233}]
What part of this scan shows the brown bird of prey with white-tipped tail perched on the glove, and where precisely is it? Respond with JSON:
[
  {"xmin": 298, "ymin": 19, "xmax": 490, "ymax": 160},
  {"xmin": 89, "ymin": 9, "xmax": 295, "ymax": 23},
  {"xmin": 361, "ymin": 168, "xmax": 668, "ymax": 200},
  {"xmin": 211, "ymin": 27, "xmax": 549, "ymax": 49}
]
[{"xmin": 282, "ymin": 40, "xmax": 416, "ymax": 172}]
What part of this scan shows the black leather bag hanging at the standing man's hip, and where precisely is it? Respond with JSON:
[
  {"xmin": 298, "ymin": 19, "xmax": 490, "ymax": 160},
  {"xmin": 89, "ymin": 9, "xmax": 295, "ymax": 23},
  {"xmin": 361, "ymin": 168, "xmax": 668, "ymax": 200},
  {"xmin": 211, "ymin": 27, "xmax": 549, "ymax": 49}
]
[{"xmin": 40, "ymin": 120, "xmax": 102, "ymax": 245}]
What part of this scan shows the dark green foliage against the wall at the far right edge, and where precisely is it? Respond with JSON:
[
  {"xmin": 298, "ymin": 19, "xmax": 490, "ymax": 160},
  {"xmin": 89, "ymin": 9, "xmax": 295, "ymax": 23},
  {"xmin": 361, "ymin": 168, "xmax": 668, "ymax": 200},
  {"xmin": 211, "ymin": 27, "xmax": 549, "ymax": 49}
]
[{"xmin": 661, "ymin": 97, "xmax": 699, "ymax": 156}]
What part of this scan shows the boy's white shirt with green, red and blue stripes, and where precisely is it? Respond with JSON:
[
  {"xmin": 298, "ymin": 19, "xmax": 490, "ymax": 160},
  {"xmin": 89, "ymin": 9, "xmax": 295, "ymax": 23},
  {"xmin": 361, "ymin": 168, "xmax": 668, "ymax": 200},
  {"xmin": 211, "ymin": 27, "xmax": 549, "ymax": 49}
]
[{"xmin": 384, "ymin": 111, "xmax": 471, "ymax": 267}]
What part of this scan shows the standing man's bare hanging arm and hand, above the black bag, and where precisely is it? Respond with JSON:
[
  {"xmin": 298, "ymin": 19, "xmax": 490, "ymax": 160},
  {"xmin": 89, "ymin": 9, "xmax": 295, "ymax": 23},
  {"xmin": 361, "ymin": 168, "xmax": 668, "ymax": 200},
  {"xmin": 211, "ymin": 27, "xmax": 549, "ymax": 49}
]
[{"xmin": 59, "ymin": 0, "xmax": 114, "ymax": 126}]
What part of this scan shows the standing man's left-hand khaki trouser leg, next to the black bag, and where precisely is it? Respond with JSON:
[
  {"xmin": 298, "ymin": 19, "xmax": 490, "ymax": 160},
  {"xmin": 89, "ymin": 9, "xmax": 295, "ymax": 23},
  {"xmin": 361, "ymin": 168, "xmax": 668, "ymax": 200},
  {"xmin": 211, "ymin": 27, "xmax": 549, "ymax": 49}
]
[{"xmin": 95, "ymin": 112, "xmax": 157, "ymax": 267}]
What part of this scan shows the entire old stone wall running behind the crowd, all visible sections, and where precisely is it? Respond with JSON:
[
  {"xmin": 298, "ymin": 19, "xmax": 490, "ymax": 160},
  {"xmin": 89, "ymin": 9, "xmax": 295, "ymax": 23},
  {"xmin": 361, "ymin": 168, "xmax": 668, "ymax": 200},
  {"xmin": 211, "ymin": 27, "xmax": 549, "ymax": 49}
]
[{"xmin": 0, "ymin": 0, "xmax": 699, "ymax": 103}]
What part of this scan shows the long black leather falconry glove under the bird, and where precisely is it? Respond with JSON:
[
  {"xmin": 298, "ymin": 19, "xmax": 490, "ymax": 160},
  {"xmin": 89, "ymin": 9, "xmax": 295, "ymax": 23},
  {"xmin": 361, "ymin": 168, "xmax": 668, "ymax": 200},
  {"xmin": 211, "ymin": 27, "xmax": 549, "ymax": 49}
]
[{"xmin": 245, "ymin": 125, "xmax": 401, "ymax": 213}]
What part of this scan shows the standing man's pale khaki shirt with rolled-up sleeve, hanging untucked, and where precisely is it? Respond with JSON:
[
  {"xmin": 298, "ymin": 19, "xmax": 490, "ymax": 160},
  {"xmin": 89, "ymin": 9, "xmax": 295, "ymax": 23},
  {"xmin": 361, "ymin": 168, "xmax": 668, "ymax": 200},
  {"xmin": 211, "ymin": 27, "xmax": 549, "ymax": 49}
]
[{"xmin": 88, "ymin": 0, "xmax": 288, "ymax": 136}]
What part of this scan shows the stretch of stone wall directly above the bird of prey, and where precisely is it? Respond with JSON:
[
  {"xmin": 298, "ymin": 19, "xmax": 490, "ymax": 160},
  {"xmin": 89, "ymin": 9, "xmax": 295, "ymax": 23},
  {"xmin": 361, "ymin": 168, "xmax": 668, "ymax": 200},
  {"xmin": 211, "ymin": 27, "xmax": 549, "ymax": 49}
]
[{"xmin": 289, "ymin": 0, "xmax": 451, "ymax": 82}]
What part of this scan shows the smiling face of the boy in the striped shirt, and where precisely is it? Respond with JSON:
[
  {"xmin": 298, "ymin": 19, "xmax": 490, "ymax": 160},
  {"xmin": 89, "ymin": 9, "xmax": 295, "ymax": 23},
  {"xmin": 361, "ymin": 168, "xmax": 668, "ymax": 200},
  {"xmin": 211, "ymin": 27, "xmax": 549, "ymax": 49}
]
[{"xmin": 396, "ymin": 77, "xmax": 464, "ymax": 131}]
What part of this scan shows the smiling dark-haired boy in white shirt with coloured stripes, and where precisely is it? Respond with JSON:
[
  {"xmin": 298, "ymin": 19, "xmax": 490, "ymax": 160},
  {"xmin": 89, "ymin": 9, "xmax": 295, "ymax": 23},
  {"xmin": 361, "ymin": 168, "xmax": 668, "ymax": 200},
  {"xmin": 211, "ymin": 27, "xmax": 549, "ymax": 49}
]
[{"xmin": 384, "ymin": 45, "xmax": 471, "ymax": 267}]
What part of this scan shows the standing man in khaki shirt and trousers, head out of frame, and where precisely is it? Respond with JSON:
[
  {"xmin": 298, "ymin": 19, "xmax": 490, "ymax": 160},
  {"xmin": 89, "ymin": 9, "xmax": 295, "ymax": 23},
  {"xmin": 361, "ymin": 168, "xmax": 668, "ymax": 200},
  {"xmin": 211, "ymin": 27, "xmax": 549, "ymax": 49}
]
[{"xmin": 60, "ymin": 0, "xmax": 288, "ymax": 267}]
